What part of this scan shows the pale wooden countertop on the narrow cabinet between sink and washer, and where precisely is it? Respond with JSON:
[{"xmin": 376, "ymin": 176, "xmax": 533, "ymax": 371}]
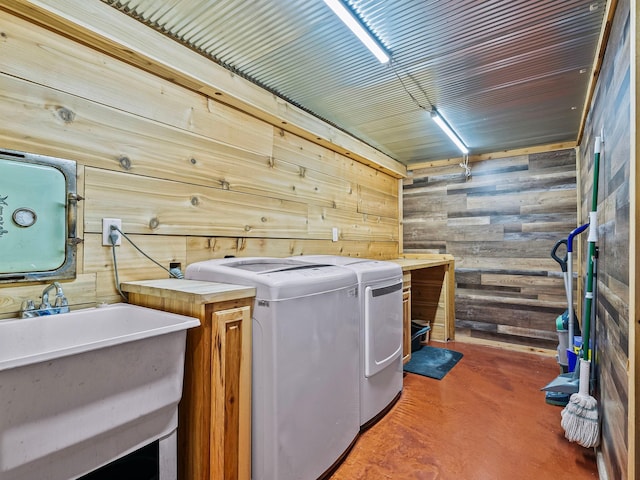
[{"xmin": 120, "ymin": 278, "xmax": 256, "ymax": 303}]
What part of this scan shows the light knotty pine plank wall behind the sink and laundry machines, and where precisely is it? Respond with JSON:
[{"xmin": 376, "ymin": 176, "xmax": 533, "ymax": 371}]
[{"xmin": 0, "ymin": 10, "xmax": 400, "ymax": 318}]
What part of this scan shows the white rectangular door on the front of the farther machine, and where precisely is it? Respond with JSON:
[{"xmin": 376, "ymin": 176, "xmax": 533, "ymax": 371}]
[{"xmin": 364, "ymin": 282, "xmax": 402, "ymax": 377}]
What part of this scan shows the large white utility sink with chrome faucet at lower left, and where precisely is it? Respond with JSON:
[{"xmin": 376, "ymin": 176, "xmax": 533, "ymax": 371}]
[{"xmin": 0, "ymin": 304, "xmax": 200, "ymax": 480}]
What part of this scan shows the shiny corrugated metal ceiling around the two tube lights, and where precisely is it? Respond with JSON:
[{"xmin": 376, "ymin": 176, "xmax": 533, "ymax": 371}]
[{"xmin": 103, "ymin": 0, "xmax": 606, "ymax": 165}]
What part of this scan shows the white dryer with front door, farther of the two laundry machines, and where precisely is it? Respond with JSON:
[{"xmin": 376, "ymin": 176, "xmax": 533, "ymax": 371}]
[{"xmin": 292, "ymin": 255, "xmax": 402, "ymax": 428}]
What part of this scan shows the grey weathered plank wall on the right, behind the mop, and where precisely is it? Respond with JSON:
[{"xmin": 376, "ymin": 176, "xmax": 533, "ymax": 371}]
[{"xmin": 579, "ymin": 0, "xmax": 637, "ymax": 479}]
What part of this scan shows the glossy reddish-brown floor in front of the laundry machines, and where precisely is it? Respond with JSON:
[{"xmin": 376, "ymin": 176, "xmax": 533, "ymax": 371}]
[{"xmin": 330, "ymin": 342, "xmax": 598, "ymax": 480}]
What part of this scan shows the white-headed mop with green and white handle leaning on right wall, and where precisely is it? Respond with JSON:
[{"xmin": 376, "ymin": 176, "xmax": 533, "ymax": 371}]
[{"xmin": 560, "ymin": 137, "xmax": 600, "ymax": 448}]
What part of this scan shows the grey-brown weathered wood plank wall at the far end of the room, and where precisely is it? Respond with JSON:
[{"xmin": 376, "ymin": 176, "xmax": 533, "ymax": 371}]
[{"xmin": 403, "ymin": 149, "xmax": 577, "ymax": 348}]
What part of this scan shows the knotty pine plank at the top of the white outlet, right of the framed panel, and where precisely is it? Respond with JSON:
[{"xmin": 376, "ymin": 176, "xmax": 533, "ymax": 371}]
[{"xmin": 84, "ymin": 168, "xmax": 308, "ymax": 238}]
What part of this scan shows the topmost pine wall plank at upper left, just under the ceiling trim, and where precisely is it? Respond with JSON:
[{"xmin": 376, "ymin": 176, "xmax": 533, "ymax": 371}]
[{"xmin": 0, "ymin": 7, "xmax": 272, "ymax": 156}]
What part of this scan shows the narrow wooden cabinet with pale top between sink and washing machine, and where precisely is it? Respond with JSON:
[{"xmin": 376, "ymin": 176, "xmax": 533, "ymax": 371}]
[{"xmin": 122, "ymin": 279, "xmax": 255, "ymax": 480}]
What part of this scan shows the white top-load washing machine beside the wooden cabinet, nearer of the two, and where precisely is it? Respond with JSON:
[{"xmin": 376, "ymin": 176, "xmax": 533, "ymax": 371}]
[{"xmin": 185, "ymin": 257, "xmax": 360, "ymax": 480}]
